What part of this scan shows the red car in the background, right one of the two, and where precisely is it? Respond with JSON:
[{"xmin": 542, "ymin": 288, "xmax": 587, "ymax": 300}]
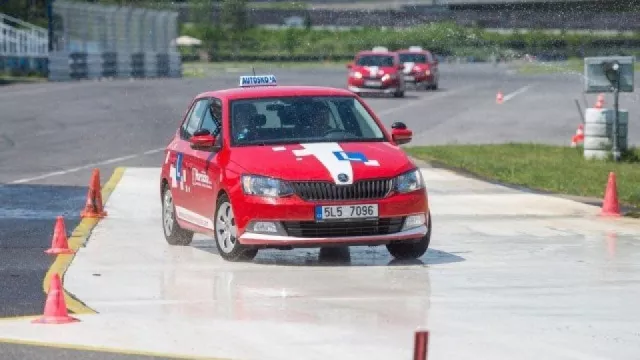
[{"xmin": 396, "ymin": 46, "xmax": 440, "ymax": 90}]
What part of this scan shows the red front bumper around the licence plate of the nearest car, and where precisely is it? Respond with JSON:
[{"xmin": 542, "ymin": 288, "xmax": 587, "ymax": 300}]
[{"xmin": 231, "ymin": 190, "xmax": 431, "ymax": 247}]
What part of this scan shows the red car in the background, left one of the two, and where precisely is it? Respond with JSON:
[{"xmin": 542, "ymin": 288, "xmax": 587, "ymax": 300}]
[{"xmin": 347, "ymin": 47, "xmax": 406, "ymax": 97}]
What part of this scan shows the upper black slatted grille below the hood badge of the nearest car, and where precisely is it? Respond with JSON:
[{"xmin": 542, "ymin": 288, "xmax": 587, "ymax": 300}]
[{"xmin": 291, "ymin": 179, "xmax": 393, "ymax": 201}]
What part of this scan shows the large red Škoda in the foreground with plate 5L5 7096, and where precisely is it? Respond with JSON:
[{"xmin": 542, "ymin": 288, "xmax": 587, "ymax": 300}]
[{"xmin": 159, "ymin": 75, "xmax": 431, "ymax": 261}]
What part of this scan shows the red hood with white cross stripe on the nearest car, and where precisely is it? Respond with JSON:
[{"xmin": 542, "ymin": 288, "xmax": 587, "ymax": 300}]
[{"xmin": 230, "ymin": 142, "xmax": 415, "ymax": 184}]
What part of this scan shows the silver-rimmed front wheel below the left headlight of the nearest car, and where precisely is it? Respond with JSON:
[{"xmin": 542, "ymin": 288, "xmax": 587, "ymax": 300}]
[{"xmin": 214, "ymin": 194, "xmax": 258, "ymax": 261}]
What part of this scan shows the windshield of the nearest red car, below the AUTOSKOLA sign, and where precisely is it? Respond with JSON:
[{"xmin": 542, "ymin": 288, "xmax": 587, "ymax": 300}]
[{"xmin": 231, "ymin": 96, "xmax": 386, "ymax": 146}]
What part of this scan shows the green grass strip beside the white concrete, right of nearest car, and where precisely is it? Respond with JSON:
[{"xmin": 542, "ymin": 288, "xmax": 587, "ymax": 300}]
[{"xmin": 406, "ymin": 143, "xmax": 640, "ymax": 213}]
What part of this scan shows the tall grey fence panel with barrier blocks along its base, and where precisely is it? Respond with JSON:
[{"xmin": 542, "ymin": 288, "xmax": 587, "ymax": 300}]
[{"xmin": 49, "ymin": 0, "xmax": 182, "ymax": 80}]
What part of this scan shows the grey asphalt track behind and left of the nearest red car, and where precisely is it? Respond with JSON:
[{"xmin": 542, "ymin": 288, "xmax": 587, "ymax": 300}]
[{"xmin": 0, "ymin": 65, "xmax": 640, "ymax": 359}]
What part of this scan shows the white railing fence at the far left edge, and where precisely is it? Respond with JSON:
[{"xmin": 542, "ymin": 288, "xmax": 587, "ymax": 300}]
[{"xmin": 0, "ymin": 13, "xmax": 48, "ymax": 73}]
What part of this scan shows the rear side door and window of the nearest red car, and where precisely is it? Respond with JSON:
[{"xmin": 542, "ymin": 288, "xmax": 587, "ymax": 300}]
[{"xmin": 167, "ymin": 99, "xmax": 210, "ymax": 228}]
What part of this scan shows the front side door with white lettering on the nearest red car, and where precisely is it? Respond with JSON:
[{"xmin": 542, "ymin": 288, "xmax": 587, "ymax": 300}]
[{"xmin": 189, "ymin": 98, "xmax": 223, "ymax": 226}]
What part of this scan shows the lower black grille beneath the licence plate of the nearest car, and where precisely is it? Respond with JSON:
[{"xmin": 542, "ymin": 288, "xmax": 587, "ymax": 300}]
[{"xmin": 283, "ymin": 217, "xmax": 404, "ymax": 238}]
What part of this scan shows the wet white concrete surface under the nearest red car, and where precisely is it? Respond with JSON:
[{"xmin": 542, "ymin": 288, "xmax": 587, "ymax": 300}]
[{"xmin": 0, "ymin": 168, "xmax": 640, "ymax": 360}]
